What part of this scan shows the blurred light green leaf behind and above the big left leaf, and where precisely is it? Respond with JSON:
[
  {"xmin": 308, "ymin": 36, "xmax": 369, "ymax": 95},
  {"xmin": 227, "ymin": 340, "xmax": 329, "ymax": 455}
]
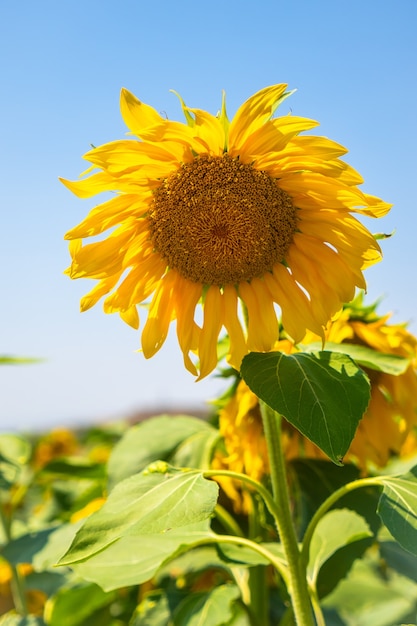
[{"xmin": 108, "ymin": 415, "xmax": 218, "ymax": 489}]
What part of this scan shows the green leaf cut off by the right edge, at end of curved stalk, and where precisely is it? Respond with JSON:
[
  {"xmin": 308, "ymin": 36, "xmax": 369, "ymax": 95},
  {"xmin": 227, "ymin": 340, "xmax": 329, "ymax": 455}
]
[{"xmin": 378, "ymin": 466, "xmax": 417, "ymax": 555}]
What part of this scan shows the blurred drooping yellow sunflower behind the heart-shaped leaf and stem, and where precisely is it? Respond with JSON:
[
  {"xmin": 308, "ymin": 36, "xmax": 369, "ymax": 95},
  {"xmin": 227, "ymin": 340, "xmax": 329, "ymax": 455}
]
[{"xmin": 213, "ymin": 298, "xmax": 417, "ymax": 512}]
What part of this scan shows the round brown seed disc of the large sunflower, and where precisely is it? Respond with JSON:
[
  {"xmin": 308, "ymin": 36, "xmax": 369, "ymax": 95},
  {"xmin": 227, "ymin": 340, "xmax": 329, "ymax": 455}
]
[{"xmin": 149, "ymin": 154, "xmax": 297, "ymax": 285}]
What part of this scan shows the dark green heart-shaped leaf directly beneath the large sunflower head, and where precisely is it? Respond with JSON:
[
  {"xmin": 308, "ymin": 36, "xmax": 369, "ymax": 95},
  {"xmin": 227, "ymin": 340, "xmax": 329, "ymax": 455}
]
[{"xmin": 241, "ymin": 352, "xmax": 370, "ymax": 465}]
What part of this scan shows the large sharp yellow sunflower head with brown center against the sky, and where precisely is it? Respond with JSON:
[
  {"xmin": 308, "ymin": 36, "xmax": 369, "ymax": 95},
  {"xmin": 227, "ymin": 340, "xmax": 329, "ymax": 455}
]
[{"xmin": 63, "ymin": 84, "xmax": 390, "ymax": 377}]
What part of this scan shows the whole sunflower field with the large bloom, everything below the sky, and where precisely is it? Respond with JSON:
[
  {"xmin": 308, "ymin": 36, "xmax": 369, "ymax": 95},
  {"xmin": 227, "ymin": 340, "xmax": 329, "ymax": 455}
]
[{"xmin": 0, "ymin": 84, "xmax": 417, "ymax": 626}]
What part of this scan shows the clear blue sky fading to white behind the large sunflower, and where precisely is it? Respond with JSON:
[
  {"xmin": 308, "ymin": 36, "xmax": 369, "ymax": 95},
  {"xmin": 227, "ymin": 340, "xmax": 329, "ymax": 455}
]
[{"xmin": 0, "ymin": 0, "xmax": 417, "ymax": 431}]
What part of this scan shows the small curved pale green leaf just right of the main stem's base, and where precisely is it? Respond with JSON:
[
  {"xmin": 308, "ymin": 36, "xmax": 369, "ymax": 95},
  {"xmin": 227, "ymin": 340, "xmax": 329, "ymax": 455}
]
[{"xmin": 307, "ymin": 509, "xmax": 372, "ymax": 585}]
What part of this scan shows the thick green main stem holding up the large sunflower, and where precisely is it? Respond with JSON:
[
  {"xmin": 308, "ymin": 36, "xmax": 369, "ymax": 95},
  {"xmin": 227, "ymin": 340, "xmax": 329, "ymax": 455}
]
[{"xmin": 260, "ymin": 401, "xmax": 314, "ymax": 626}]
